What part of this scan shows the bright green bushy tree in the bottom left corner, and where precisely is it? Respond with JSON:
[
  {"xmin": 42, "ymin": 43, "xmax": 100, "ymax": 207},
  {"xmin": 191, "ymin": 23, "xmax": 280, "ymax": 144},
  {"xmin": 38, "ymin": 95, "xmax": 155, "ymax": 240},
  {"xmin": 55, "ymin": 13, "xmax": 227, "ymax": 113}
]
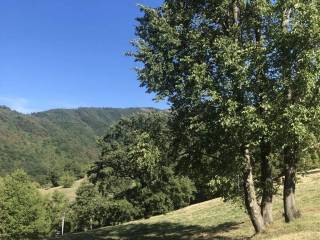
[{"xmin": 0, "ymin": 170, "xmax": 50, "ymax": 239}]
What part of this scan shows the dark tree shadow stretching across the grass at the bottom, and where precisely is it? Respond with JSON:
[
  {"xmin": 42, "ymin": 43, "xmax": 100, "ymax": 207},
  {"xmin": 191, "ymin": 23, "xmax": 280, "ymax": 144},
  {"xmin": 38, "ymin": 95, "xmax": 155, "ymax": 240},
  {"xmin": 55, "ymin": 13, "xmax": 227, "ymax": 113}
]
[{"xmin": 63, "ymin": 222, "xmax": 245, "ymax": 240}]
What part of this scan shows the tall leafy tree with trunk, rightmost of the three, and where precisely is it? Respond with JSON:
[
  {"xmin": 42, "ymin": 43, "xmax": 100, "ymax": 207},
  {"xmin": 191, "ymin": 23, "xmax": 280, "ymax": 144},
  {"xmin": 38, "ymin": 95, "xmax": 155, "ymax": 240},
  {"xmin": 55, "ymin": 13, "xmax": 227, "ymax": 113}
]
[{"xmin": 274, "ymin": 1, "xmax": 320, "ymax": 222}]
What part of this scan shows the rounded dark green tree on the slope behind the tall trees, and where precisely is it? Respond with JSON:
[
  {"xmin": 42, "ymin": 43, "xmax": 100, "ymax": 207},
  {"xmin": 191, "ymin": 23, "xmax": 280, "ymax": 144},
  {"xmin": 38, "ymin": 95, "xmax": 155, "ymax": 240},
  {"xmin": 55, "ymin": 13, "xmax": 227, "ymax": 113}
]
[{"xmin": 89, "ymin": 112, "xmax": 195, "ymax": 221}]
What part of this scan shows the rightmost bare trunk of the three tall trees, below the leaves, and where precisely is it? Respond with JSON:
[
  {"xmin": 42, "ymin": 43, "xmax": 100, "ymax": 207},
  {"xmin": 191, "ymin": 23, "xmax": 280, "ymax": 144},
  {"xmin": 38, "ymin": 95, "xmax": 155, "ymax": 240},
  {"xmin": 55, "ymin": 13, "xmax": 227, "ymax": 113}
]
[{"xmin": 283, "ymin": 148, "xmax": 300, "ymax": 222}]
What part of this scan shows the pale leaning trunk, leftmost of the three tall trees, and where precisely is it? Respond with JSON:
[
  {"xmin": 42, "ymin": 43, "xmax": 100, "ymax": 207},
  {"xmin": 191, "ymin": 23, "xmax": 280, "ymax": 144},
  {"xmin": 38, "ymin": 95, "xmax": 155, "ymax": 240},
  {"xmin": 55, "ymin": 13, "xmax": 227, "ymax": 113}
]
[{"xmin": 243, "ymin": 148, "xmax": 265, "ymax": 233}]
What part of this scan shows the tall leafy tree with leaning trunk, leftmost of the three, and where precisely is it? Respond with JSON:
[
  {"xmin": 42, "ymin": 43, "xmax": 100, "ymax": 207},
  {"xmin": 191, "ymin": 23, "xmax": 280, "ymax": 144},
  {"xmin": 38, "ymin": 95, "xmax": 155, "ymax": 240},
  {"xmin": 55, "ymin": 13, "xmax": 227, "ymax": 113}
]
[{"xmin": 134, "ymin": 1, "xmax": 272, "ymax": 232}]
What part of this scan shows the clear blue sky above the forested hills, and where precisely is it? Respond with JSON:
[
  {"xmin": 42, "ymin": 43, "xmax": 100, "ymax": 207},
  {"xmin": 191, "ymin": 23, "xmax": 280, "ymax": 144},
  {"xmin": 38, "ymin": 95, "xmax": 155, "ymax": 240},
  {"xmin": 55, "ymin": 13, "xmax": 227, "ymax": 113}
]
[{"xmin": 0, "ymin": 0, "xmax": 167, "ymax": 113}]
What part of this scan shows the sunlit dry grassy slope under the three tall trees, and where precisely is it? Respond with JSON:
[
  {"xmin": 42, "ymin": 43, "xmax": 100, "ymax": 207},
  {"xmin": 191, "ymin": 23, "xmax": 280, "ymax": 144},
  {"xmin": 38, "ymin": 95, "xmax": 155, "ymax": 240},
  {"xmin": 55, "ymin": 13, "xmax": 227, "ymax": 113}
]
[{"xmin": 58, "ymin": 173, "xmax": 320, "ymax": 240}]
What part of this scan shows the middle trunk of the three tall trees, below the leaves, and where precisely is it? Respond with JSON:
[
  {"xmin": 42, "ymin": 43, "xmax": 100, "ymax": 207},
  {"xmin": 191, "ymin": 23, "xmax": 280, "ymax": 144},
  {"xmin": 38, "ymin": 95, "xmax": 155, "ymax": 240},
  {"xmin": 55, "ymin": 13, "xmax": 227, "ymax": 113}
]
[{"xmin": 260, "ymin": 141, "xmax": 273, "ymax": 225}]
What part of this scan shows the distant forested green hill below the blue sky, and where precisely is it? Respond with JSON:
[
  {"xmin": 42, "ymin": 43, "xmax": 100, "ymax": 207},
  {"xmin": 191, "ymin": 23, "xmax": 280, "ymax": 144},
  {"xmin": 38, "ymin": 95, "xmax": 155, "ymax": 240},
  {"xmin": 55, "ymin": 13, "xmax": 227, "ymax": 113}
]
[{"xmin": 0, "ymin": 106, "xmax": 151, "ymax": 183}]
